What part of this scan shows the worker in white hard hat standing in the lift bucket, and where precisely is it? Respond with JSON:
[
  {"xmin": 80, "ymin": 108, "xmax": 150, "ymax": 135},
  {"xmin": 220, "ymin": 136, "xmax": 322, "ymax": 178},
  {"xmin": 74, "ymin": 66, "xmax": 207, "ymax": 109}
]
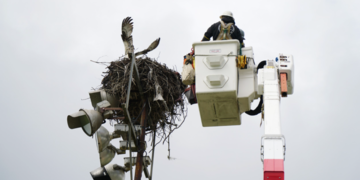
[{"xmin": 201, "ymin": 11, "xmax": 245, "ymax": 47}]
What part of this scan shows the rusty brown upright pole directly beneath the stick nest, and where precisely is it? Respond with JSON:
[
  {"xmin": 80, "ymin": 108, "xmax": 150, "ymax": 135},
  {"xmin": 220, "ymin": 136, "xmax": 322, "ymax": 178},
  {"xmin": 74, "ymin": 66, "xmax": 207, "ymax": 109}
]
[{"xmin": 134, "ymin": 101, "xmax": 149, "ymax": 180}]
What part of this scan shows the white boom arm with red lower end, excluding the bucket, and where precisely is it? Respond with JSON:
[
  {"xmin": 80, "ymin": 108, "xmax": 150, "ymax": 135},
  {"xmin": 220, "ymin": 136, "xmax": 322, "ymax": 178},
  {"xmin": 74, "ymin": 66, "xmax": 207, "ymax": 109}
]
[{"xmin": 258, "ymin": 55, "xmax": 293, "ymax": 180}]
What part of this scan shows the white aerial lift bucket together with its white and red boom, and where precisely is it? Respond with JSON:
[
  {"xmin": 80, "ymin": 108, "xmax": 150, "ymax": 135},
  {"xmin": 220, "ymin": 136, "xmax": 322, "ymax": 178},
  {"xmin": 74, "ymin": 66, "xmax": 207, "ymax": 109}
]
[{"xmin": 193, "ymin": 40, "xmax": 294, "ymax": 180}]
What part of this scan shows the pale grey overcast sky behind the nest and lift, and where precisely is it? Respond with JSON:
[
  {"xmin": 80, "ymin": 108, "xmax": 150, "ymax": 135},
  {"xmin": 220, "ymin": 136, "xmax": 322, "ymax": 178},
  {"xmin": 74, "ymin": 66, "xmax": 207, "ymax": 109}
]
[{"xmin": 0, "ymin": 0, "xmax": 360, "ymax": 180}]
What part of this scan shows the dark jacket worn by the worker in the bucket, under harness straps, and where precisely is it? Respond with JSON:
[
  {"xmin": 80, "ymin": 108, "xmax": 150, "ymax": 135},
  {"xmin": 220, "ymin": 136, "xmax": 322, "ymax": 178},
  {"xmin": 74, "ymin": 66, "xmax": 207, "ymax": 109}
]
[{"xmin": 202, "ymin": 18, "xmax": 245, "ymax": 47}]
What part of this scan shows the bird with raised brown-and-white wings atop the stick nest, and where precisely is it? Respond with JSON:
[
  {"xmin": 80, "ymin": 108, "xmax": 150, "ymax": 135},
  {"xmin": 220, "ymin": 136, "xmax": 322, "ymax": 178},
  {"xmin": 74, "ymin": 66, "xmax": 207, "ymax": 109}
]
[{"xmin": 121, "ymin": 17, "xmax": 160, "ymax": 57}]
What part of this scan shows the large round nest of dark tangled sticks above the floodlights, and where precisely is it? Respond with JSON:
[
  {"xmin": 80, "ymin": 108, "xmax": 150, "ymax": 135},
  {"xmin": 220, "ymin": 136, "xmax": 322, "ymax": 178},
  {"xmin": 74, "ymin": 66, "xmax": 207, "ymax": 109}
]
[{"xmin": 101, "ymin": 56, "xmax": 187, "ymax": 141}]
